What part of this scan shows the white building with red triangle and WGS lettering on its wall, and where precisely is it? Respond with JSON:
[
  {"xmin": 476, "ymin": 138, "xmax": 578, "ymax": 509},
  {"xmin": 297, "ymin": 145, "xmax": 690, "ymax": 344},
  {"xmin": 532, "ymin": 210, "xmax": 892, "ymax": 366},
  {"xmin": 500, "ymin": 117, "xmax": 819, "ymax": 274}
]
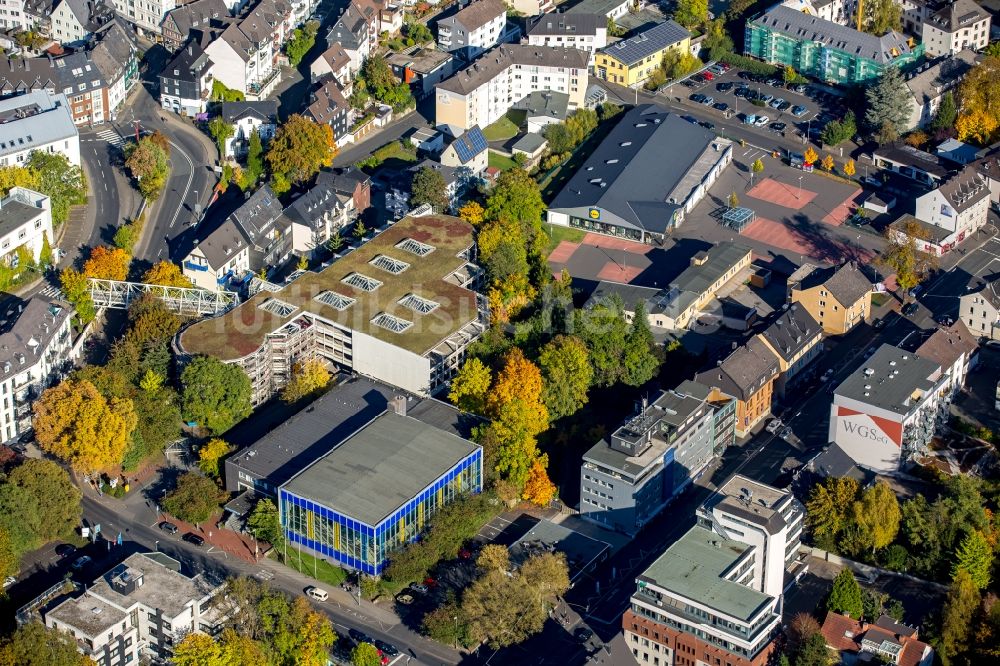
[{"xmin": 829, "ymin": 344, "xmax": 951, "ymax": 474}]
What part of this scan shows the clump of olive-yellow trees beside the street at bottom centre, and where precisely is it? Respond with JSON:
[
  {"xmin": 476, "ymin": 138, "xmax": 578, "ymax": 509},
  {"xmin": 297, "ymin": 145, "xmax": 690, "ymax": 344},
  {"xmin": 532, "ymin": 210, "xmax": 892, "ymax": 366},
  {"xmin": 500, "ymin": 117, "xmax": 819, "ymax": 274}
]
[{"xmin": 423, "ymin": 544, "xmax": 569, "ymax": 649}]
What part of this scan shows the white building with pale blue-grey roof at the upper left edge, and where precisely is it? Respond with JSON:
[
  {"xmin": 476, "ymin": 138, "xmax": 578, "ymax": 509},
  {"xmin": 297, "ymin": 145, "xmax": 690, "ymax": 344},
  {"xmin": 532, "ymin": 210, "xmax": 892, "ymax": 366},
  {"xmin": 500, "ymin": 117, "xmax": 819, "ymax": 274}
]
[{"xmin": 0, "ymin": 90, "xmax": 80, "ymax": 166}]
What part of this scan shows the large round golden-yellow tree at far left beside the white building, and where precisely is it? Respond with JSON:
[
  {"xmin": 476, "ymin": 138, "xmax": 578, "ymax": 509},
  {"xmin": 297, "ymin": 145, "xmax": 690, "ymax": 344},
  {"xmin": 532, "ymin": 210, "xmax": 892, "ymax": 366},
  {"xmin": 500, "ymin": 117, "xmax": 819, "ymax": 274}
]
[{"xmin": 33, "ymin": 380, "xmax": 137, "ymax": 472}]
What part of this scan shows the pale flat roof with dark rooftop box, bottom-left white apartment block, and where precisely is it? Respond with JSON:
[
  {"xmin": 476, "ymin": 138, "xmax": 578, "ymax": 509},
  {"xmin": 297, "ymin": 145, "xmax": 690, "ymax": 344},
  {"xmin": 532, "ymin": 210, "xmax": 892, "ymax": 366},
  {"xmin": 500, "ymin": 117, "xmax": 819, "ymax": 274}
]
[{"xmin": 87, "ymin": 553, "xmax": 217, "ymax": 620}]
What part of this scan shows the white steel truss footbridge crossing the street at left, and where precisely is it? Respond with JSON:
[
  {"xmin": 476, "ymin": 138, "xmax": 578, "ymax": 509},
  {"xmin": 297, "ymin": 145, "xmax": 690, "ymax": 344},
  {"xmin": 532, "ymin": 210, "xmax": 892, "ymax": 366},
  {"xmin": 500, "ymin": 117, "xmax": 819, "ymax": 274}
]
[{"xmin": 87, "ymin": 278, "xmax": 240, "ymax": 316}]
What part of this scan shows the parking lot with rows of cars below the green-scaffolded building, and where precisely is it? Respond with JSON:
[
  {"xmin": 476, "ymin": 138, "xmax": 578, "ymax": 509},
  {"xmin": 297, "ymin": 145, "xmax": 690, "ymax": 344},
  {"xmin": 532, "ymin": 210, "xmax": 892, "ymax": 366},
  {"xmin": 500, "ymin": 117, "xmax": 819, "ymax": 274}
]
[{"xmin": 660, "ymin": 66, "xmax": 847, "ymax": 141}]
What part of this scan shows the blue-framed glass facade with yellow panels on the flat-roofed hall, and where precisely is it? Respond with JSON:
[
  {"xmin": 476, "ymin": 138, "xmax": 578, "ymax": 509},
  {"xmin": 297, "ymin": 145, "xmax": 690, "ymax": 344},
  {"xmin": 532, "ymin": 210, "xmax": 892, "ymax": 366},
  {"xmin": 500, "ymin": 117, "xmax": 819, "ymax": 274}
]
[{"xmin": 278, "ymin": 447, "xmax": 483, "ymax": 575}]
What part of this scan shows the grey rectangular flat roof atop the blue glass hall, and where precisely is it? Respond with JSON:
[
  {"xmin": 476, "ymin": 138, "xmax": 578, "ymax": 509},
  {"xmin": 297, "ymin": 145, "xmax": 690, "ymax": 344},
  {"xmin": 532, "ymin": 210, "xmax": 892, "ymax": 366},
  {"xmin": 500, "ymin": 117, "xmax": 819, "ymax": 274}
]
[{"xmin": 283, "ymin": 411, "xmax": 479, "ymax": 527}]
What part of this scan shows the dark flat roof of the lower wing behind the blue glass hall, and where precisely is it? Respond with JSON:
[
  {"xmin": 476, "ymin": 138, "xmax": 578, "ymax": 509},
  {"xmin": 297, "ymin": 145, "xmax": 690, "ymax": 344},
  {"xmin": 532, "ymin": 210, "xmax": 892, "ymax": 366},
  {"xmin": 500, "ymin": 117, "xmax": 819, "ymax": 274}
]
[{"xmin": 227, "ymin": 377, "xmax": 481, "ymax": 487}]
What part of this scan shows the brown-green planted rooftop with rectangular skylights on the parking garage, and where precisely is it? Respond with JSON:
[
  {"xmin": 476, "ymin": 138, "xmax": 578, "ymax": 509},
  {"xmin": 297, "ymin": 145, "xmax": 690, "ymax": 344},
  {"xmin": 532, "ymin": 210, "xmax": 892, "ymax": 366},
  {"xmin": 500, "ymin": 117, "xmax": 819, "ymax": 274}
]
[{"xmin": 180, "ymin": 215, "xmax": 478, "ymax": 361}]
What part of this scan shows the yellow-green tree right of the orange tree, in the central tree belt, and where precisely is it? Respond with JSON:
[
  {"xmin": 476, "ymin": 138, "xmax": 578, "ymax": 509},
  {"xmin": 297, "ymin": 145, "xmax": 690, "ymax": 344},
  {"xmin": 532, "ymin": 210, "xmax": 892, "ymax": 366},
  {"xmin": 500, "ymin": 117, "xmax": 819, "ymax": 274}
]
[{"xmin": 538, "ymin": 335, "xmax": 594, "ymax": 420}]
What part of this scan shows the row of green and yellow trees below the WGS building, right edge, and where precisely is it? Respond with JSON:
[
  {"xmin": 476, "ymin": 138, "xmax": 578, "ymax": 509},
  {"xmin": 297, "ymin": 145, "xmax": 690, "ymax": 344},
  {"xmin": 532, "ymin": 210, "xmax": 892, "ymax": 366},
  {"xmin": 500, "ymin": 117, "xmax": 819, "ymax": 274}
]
[{"xmin": 806, "ymin": 476, "xmax": 997, "ymax": 589}]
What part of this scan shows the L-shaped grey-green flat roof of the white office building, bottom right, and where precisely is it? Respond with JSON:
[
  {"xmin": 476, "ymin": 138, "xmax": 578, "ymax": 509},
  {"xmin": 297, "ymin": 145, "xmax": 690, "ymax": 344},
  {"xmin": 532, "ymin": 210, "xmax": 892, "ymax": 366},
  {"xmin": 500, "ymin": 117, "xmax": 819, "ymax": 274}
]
[{"xmin": 638, "ymin": 527, "xmax": 773, "ymax": 622}]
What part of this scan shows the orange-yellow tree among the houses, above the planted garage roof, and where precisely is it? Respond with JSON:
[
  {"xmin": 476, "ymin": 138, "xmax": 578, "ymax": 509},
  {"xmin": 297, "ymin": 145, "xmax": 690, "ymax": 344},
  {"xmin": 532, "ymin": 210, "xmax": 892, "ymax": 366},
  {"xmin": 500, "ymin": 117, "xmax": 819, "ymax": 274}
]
[{"xmin": 267, "ymin": 113, "xmax": 337, "ymax": 195}]
